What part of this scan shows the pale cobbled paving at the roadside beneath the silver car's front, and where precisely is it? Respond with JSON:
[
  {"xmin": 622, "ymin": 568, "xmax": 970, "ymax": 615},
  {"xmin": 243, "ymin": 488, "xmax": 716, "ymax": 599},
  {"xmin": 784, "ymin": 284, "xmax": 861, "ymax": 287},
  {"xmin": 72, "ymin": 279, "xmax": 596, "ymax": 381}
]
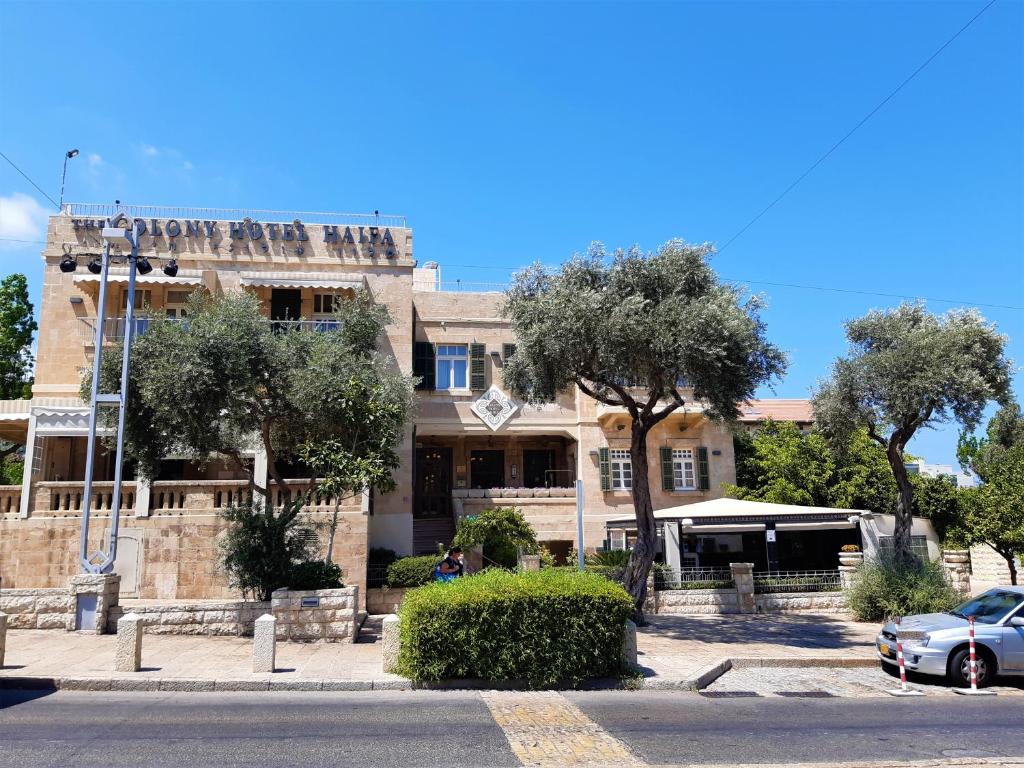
[{"xmin": 703, "ymin": 667, "xmax": 1024, "ymax": 698}]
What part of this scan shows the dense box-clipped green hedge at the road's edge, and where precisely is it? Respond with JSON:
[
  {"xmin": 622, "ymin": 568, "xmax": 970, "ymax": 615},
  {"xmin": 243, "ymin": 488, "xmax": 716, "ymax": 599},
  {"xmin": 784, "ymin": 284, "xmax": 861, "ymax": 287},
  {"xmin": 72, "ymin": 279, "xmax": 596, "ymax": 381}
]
[{"xmin": 398, "ymin": 568, "xmax": 633, "ymax": 688}]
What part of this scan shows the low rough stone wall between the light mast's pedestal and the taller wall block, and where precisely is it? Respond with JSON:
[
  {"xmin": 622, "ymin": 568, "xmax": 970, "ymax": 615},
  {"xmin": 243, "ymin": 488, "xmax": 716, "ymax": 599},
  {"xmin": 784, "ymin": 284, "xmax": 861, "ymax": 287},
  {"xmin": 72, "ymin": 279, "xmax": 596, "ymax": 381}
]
[{"xmin": 106, "ymin": 600, "xmax": 270, "ymax": 637}]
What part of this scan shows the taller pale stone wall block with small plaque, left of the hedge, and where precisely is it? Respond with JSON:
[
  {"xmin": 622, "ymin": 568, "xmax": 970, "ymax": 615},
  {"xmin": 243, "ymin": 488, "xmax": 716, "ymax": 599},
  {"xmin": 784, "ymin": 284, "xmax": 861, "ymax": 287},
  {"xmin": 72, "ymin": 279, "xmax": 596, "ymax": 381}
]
[{"xmin": 270, "ymin": 587, "xmax": 359, "ymax": 643}]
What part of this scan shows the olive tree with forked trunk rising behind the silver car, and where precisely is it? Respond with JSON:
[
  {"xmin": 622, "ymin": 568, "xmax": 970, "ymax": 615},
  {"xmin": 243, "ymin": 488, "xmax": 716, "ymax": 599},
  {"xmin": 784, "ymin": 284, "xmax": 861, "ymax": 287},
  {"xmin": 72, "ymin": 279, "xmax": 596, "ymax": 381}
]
[{"xmin": 814, "ymin": 303, "xmax": 1011, "ymax": 562}]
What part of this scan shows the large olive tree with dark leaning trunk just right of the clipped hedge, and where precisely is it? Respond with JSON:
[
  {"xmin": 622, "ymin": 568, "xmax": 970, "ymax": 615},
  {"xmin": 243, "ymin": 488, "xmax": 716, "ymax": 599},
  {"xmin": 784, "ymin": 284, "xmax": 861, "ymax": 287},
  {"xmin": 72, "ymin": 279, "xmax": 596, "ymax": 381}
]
[{"xmin": 504, "ymin": 241, "xmax": 785, "ymax": 621}]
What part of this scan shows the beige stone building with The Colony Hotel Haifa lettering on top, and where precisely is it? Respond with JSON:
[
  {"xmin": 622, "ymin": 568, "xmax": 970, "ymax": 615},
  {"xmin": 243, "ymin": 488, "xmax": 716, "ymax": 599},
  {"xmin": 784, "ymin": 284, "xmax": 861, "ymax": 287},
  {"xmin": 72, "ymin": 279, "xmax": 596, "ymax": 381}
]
[{"xmin": 0, "ymin": 205, "xmax": 810, "ymax": 599}]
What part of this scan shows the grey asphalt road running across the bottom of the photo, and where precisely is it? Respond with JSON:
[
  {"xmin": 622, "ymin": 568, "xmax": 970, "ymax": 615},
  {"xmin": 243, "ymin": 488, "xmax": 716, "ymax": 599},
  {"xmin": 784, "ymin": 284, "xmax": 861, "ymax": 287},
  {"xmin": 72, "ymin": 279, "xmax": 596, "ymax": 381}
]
[{"xmin": 0, "ymin": 691, "xmax": 1024, "ymax": 768}]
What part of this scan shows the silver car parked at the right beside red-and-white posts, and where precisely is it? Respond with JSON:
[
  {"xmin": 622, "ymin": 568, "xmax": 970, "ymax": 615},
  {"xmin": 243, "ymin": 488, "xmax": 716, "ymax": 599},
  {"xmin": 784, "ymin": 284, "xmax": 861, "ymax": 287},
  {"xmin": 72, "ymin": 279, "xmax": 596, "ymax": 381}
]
[{"xmin": 874, "ymin": 587, "xmax": 1024, "ymax": 687}]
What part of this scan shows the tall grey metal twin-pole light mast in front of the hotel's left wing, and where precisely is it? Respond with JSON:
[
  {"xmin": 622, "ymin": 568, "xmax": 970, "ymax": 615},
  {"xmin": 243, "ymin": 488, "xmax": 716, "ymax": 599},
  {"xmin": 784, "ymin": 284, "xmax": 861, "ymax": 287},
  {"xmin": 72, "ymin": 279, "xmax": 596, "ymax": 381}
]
[{"xmin": 79, "ymin": 213, "xmax": 139, "ymax": 573}]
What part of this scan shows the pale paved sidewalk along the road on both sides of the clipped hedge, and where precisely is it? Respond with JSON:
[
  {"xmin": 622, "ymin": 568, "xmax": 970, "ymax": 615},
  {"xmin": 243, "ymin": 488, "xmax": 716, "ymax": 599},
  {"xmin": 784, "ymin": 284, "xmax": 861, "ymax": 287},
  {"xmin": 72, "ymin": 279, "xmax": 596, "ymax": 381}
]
[{"xmin": 0, "ymin": 615, "xmax": 878, "ymax": 690}]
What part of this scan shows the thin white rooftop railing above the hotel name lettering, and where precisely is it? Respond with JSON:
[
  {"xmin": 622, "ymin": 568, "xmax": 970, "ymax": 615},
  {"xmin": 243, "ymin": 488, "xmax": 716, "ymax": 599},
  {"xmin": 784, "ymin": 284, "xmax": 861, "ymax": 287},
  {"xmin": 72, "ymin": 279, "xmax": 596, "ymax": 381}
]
[{"xmin": 63, "ymin": 203, "xmax": 407, "ymax": 227}]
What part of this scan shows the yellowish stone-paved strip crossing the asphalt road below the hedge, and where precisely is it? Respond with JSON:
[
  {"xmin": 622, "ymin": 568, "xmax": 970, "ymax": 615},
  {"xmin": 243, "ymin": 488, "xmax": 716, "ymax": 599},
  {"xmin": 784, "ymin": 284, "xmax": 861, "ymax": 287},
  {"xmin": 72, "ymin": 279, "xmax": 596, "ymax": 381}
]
[{"xmin": 480, "ymin": 691, "xmax": 645, "ymax": 768}]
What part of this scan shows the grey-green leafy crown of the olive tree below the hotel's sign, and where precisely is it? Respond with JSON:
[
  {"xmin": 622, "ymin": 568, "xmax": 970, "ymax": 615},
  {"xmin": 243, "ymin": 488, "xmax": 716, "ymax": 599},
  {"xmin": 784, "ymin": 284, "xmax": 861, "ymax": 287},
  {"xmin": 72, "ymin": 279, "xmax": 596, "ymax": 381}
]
[{"xmin": 82, "ymin": 292, "xmax": 413, "ymax": 496}]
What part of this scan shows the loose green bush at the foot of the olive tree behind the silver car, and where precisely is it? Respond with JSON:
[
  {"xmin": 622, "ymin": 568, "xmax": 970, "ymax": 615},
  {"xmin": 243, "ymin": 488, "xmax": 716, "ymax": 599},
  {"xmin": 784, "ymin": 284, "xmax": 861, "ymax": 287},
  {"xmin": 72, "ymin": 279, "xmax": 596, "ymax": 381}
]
[{"xmin": 847, "ymin": 557, "xmax": 961, "ymax": 622}]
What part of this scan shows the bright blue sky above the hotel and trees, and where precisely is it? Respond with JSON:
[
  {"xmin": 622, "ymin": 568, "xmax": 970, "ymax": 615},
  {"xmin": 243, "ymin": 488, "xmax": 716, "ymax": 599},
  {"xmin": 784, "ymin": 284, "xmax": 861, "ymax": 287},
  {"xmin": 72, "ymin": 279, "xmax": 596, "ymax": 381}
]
[{"xmin": 0, "ymin": 0, "xmax": 1024, "ymax": 463}]
